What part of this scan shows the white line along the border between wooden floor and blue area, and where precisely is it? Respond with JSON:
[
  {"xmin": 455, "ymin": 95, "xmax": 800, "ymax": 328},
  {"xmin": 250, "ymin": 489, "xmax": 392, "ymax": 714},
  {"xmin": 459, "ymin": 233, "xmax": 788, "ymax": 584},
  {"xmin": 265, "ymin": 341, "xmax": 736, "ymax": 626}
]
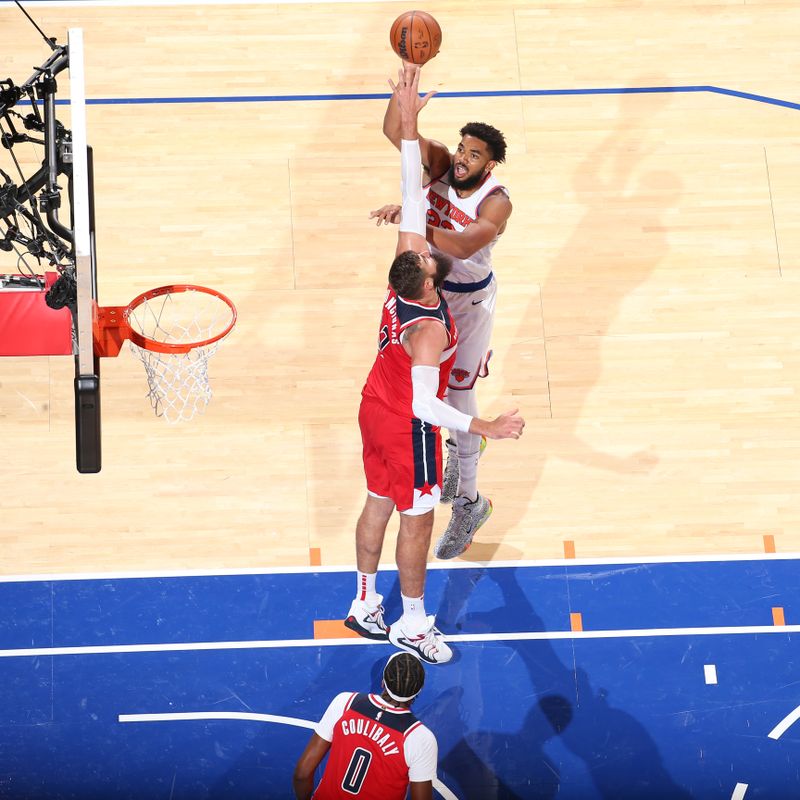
[{"xmin": 0, "ymin": 553, "xmax": 800, "ymax": 583}]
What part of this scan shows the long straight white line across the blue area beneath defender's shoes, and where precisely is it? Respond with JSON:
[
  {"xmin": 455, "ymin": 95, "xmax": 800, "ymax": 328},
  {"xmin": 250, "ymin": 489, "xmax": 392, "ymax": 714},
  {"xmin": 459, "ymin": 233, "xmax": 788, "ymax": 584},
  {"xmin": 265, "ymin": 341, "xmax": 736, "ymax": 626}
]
[{"xmin": 0, "ymin": 625, "xmax": 800, "ymax": 660}]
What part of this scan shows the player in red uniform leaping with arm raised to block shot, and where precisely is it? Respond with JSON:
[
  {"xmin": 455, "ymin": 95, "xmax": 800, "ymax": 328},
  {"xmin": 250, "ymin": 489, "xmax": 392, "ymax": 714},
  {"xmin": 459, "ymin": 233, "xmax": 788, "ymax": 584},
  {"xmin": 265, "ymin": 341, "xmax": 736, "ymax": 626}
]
[{"xmin": 345, "ymin": 65, "xmax": 525, "ymax": 664}]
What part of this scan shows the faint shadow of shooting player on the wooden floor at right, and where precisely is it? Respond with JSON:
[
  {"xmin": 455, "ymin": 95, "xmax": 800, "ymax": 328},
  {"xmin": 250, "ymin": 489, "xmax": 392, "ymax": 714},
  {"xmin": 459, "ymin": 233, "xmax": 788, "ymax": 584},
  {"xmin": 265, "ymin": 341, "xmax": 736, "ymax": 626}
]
[{"xmin": 466, "ymin": 75, "xmax": 683, "ymax": 561}]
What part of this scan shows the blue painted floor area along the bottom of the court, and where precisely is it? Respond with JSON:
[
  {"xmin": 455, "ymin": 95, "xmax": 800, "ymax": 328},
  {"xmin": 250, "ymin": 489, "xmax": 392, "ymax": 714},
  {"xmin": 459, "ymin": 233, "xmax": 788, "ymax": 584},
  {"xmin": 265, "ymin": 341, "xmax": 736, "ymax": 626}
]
[{"xmin": 0, "ymin": 557, "xmax": 800, "ymax": 800}]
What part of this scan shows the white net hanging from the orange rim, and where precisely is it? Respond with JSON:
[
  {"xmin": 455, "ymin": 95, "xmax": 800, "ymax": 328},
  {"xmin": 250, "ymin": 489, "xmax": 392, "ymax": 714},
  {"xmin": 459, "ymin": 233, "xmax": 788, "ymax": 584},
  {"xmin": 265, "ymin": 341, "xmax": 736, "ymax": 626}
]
[{"xmin": 128, "ymin": 289, "xmax": 234, "ymax": 423}]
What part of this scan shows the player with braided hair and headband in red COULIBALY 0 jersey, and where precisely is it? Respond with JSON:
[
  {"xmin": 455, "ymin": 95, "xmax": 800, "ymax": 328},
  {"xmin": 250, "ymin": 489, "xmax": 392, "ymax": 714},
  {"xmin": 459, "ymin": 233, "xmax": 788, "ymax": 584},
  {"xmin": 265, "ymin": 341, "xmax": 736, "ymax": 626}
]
[{"xmin": 294, "ymin": 653, "xmax": 438, "ymax": 800}]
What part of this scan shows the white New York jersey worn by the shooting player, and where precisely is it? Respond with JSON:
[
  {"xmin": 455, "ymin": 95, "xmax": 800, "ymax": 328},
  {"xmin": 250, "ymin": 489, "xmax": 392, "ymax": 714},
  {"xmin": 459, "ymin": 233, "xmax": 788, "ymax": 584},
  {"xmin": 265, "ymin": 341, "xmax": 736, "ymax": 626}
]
[{"xmin": 425, "ymin": 172, "xmax": 508, "ymax": 283}]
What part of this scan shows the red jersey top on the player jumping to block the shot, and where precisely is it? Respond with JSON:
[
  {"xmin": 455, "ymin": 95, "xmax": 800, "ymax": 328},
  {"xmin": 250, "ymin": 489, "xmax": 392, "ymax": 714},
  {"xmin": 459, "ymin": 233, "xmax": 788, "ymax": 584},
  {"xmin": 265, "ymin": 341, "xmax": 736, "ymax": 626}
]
[{"xmin": 361, "ymin": 287, "xmax": 458, "ymax": 419}]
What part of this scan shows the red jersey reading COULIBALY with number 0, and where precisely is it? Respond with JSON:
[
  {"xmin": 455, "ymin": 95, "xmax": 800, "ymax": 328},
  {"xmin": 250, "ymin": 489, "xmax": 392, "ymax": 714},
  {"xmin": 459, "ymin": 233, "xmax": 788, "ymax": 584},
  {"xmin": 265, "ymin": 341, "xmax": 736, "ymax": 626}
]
[{"xmin": 313, "ymin": 693, "xmax": 438, "ymax": 800}]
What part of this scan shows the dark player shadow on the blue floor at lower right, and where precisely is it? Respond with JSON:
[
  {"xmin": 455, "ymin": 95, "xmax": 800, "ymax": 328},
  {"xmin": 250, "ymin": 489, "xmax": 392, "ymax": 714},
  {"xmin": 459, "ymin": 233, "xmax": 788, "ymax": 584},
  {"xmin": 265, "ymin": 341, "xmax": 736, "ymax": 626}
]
[{"xmin": 426, "ymin": 569, "xmax": 691, "ymax": 800}]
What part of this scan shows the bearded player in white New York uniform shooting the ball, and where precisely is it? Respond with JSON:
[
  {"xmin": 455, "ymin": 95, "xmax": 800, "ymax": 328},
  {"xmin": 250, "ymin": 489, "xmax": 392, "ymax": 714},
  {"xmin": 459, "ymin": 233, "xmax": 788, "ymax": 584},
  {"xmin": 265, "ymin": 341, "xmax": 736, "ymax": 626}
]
[{"xmin": 371, "ymin": 78, "xmax": 512, "ymax": 558}]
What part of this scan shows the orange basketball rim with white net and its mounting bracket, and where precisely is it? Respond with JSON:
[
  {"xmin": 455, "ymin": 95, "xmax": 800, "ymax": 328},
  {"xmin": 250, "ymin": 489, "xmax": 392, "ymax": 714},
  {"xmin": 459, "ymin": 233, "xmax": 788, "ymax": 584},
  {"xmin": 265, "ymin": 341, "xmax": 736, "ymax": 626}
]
[{"xmin": 94, "ymin": 284, "xmax": 236, "ymax": 422}]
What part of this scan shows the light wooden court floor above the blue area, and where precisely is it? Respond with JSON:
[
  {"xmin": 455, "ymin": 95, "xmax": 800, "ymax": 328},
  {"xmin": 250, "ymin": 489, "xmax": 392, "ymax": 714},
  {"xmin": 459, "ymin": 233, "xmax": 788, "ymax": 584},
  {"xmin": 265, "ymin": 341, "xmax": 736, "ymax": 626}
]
[{"xmin": 0, "ymin": 0, "xmax": 800, "ymax": 574}]
